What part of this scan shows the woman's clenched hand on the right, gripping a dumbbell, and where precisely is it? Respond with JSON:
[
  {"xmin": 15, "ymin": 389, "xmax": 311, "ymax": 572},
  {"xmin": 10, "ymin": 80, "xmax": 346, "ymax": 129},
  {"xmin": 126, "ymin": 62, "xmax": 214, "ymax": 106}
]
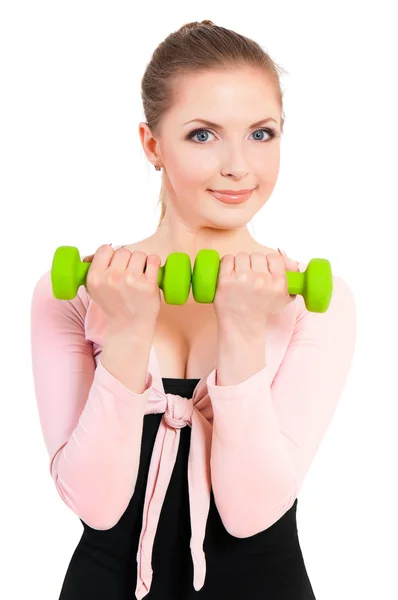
[{"xmin": 213, "ymin": 252, "xmax": 300, "ymax": 333}]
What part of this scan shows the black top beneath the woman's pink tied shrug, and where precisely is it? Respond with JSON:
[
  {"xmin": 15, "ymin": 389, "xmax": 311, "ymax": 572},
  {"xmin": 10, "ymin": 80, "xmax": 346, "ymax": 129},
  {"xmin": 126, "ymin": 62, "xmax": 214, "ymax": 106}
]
[{"xmin": 59, "ymin": 378, "xmax": 316, "ymax": 600}]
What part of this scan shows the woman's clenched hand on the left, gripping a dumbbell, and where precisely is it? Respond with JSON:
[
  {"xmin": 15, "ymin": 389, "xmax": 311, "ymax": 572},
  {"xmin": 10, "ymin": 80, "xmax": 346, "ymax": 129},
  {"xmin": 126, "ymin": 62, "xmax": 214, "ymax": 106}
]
[{"xmin": 83, "ymin": 244, "xmax": 161, "ymax": 328}]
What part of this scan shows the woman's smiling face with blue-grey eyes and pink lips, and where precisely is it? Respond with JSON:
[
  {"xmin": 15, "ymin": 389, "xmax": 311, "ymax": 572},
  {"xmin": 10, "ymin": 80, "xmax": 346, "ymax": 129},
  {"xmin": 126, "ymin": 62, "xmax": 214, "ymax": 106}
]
[{"xmin": 140, "ymin": 69, "xmax": 281, "ymax": 229}]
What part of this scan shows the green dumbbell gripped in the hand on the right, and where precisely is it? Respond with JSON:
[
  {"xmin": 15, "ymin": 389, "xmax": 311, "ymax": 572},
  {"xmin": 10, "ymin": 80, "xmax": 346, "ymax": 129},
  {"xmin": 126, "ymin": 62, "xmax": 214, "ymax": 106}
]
[{"xmin": 192, "ymin": 250, "xmax": 333, "ymax": 312}]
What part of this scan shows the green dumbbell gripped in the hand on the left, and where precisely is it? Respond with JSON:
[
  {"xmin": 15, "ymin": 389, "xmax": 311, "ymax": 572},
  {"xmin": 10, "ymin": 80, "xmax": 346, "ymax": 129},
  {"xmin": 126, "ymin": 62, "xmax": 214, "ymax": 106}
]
[{"xmin": 51, "ymin": 246, "xmax": 192, "ymax": 304}]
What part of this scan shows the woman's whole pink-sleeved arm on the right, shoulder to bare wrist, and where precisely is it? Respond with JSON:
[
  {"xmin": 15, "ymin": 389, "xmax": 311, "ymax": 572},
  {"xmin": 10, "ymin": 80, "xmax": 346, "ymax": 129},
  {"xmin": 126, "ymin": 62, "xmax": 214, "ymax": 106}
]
[{"xmin": 208, "ymin": 276, "xmax": 356, "ymax": 538}]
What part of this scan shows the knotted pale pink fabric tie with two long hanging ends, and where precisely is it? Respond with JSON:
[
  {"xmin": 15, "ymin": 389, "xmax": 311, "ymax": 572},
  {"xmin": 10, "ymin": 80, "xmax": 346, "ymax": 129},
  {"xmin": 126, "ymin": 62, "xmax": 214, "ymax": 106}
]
[{"xmin": 135, "ymin": 380, "xmax": 212, "ymax": 600}]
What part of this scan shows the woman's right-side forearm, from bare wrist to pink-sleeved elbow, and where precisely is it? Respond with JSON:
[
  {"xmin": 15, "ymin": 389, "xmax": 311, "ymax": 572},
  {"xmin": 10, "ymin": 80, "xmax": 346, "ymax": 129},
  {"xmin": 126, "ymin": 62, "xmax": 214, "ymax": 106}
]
[{"xmin": 210, "ymin": 331, "xmax": 294, "ymax": 537}]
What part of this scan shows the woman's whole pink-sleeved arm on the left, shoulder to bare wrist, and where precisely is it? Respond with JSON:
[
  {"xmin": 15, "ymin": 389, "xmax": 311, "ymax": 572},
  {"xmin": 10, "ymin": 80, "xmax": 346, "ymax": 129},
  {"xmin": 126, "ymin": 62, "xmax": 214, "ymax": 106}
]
[{"xmin": 31, "ymin": 272, "xmax": 152, "ymax": 529}]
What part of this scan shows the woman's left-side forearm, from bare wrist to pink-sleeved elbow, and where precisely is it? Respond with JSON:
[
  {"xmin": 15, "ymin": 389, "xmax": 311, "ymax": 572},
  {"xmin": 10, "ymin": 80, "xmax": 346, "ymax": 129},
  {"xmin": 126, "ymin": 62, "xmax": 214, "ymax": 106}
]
[{"xmin": 51, "ymin": 322, "xmax": 152, "ymax": 529}]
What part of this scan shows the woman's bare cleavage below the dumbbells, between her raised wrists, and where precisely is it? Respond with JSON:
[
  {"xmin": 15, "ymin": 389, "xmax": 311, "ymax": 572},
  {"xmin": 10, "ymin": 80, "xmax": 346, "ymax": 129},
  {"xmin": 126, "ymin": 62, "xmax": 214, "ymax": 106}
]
[{"xmin": 153, "ymin": 300, "xmax": 217, "ymax": 379}]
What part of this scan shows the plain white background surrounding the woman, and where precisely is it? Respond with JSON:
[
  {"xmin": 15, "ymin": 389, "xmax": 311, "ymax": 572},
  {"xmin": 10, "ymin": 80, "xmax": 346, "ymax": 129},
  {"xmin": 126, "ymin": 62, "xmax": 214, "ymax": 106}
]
[{"xmin": 0, "ymin": 0, "xmax": 398, "ymax": 600}]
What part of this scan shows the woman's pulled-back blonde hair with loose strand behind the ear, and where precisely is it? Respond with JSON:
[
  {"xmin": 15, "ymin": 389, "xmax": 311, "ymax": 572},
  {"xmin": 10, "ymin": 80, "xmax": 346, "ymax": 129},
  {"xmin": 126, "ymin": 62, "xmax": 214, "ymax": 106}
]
[{"xmin": 141, "ymin": 20, "xmax": 286, "ymax": 228}]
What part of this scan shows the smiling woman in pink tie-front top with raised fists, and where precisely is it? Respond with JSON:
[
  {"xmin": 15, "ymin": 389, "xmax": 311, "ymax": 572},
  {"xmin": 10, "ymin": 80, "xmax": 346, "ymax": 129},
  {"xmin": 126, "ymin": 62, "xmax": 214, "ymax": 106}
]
[{"xmin": 32, "ymin": 21, "xmax": 356, "ymax": 600}]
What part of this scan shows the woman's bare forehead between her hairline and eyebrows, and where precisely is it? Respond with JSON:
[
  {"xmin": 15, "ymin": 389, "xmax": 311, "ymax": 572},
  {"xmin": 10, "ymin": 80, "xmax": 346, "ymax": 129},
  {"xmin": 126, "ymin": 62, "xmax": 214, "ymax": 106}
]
[{"xmin": 168, "ymin": 68, "xmax": 280, "ymax": 123}]
